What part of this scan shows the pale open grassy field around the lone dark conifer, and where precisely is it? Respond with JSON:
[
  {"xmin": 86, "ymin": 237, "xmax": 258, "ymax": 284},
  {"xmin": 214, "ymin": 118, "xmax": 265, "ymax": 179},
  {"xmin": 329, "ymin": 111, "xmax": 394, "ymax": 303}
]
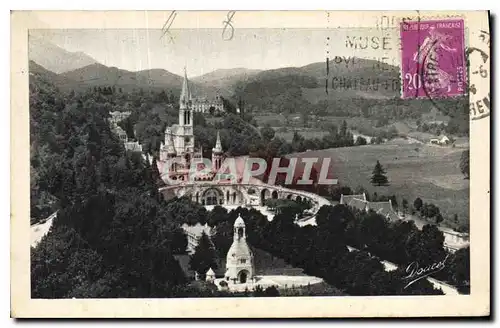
[{"xmin": 288, "ymin": 140, "xmax": 469, "ymax": 226}]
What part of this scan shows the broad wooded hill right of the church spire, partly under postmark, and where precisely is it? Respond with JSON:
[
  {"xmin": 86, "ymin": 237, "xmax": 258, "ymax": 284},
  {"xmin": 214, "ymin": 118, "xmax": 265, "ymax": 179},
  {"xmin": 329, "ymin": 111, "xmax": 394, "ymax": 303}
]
[{"xmin": 219, "ymin": 58, "xmax": 400, "ymax": 114}]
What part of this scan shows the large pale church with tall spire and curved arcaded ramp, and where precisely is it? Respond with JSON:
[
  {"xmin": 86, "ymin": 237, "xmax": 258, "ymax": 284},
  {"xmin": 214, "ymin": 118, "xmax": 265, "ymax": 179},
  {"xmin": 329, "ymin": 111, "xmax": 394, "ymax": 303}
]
[{"xmin": 156, "ymin": 68, "xmax": 330, "ymax": 220}]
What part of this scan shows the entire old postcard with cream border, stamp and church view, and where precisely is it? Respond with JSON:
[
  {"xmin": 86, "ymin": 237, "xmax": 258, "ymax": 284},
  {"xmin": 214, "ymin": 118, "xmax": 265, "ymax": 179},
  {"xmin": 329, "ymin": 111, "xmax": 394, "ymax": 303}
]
[{"xmin": 11, "ymin": 10, "xmax": 491, "ymax": 318}]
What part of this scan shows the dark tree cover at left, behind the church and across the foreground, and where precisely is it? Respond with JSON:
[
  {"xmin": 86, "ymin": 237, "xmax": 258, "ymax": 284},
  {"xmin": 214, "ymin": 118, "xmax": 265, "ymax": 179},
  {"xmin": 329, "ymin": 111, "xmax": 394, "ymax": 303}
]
[{"xmin": 30, "ymin": 70, "xmax": 468, "ymax": 298}]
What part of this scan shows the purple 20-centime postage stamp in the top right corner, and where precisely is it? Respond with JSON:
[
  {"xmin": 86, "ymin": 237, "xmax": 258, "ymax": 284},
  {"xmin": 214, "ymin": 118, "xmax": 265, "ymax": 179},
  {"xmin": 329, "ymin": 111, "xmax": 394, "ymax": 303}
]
[{"xmin": 401, "ymin": 19, "xmax": 467, "ymax": 98}]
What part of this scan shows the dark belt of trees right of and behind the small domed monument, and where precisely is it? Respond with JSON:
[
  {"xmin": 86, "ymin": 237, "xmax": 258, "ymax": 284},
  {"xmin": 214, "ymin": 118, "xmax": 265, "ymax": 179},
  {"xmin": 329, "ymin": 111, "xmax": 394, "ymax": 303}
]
[{"xmin": 191, "ymin": 205, "xmax": 470, "ymax": 295}]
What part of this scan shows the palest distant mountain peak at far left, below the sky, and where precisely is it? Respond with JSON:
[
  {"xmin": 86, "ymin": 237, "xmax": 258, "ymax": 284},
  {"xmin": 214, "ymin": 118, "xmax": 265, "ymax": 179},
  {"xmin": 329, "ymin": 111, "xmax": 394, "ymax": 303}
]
[{"xmin": 28, "ymin": 35, "xmax": 97, "ymax": 73}]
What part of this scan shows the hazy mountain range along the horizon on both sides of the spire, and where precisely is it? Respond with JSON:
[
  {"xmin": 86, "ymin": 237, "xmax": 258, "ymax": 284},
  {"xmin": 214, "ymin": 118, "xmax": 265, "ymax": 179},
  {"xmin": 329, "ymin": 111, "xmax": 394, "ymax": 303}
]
[{"xmin": 29, "ymin": 37, "xmax": 400, "ymax": 106}]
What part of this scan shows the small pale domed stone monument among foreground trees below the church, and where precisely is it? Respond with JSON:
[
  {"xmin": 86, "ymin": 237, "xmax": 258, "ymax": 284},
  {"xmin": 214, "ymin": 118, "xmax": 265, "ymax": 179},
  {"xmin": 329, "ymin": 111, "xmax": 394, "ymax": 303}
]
[{"xmin": 225, "ymin": 215, "xmax": 254, "ymax": 283}]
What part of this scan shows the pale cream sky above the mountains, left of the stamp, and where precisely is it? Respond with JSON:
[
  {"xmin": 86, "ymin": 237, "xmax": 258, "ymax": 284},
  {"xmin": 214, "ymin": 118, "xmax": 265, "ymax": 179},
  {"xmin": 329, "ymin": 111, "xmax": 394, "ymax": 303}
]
[{"xmin": 30, "ymin": 28, "xmax": 398, "ymax": 77}]
